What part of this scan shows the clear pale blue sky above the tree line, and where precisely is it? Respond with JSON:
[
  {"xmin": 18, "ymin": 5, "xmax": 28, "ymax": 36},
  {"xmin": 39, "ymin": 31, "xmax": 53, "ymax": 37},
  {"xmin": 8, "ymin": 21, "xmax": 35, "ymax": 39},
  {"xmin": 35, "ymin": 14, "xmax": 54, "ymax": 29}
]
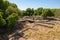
[{"xmin": 9, "ymin": 0, "xmax": 60, "ymax": 10}]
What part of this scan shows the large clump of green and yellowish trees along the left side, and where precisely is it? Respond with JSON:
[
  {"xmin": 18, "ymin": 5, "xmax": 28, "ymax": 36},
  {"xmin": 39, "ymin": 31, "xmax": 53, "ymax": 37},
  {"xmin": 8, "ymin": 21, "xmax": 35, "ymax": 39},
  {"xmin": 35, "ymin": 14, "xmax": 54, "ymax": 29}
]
[{"xmin": 0, "ymin": 0, "xmax": 20, "ymax": 27}]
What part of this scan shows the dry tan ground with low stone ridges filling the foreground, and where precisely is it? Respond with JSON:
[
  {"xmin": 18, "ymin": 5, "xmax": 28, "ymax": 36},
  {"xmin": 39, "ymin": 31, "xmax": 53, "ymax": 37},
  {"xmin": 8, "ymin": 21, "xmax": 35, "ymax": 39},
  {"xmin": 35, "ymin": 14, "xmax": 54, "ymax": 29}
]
[{"xmin": 9, "ymin": 16, "xmax": 60, "ymax": 40}]
